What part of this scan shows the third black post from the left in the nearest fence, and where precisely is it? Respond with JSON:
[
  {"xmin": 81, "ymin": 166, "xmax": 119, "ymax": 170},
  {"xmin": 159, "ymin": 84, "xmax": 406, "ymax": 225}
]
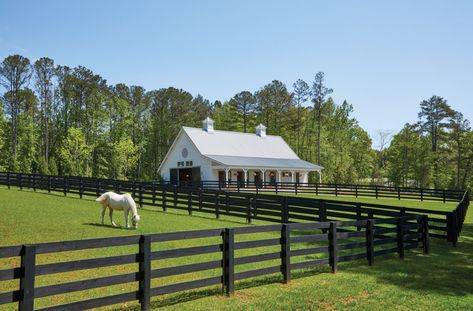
[{"xmin": 223, "ymin": 228, "xmax": 235, "ymax": 296}]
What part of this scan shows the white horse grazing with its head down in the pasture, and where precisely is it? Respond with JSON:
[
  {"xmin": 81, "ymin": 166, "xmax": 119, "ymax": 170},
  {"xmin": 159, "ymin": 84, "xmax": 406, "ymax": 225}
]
[{"xmin": 95, "ymin": 192, "xmax": 140, "ymax": 229}]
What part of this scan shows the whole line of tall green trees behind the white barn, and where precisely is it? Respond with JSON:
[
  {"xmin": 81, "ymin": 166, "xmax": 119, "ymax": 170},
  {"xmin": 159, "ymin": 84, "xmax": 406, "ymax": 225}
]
[{"xmin": 0, "ymin": 55, "xmax": 473, "ymax": 188}]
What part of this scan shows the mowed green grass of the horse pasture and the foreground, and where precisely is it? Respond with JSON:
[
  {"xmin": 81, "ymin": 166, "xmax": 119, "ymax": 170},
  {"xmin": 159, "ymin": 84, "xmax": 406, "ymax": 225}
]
[{"xmin": 0, "ymin": 188, "xmax": 473, "ymax": 310}]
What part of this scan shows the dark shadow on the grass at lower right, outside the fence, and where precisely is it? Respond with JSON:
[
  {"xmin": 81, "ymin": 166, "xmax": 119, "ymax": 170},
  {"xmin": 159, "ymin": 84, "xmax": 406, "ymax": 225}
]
[{"xmin": 341, "ymin": 224, "xmax": 473, "ymax": 296}]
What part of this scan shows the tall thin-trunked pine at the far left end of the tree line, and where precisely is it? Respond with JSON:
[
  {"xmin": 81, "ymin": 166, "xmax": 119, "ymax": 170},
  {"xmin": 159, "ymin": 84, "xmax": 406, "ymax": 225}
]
[{"xmin": 0, "ymin": 55, "xmax": 31, "ymax": 159}]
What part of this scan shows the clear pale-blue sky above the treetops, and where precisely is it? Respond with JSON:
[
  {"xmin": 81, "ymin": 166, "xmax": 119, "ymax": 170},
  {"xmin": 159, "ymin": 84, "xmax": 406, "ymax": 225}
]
[{"xmin": 0, "ymin": 0, "xmax": 473, "ymax": 147}]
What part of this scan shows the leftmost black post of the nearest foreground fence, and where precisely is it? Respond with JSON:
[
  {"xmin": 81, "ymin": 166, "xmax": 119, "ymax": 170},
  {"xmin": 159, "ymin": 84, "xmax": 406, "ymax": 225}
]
[{"xmin": 18, "ymin": 245, "xmax": 36, "ymax": 311}]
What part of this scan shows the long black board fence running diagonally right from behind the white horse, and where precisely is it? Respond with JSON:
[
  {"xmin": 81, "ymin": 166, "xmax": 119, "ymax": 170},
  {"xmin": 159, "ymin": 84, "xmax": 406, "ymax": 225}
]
[{"xmin": 0, "ymin": 173, "xmax": 470, "ymax": 245}]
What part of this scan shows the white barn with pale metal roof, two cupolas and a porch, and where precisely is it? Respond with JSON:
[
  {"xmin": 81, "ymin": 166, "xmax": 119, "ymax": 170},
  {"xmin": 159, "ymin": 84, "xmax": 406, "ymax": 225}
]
[{"xmin": 158, "ymin": 118, "xmax": 323, "ymax": 187}]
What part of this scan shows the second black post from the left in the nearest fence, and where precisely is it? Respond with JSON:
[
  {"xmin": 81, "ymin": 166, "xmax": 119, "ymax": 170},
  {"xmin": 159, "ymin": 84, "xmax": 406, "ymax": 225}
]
[{"xmin": 140, "ymin": 234, "xmax": 151, "ymax": 311}]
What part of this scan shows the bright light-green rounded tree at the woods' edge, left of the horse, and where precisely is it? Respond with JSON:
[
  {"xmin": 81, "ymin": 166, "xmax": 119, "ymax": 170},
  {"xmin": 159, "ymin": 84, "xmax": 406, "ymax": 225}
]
[{"xmin": 59, "ymin": 127, "xmax": 92, "ymax": 176}]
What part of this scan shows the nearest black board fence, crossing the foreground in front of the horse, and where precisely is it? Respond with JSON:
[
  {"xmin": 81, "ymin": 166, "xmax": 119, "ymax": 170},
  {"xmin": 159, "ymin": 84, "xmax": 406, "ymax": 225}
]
[{"xmin": 0, "ymin": 215, "xmax": 429, "ymax": 310}]
